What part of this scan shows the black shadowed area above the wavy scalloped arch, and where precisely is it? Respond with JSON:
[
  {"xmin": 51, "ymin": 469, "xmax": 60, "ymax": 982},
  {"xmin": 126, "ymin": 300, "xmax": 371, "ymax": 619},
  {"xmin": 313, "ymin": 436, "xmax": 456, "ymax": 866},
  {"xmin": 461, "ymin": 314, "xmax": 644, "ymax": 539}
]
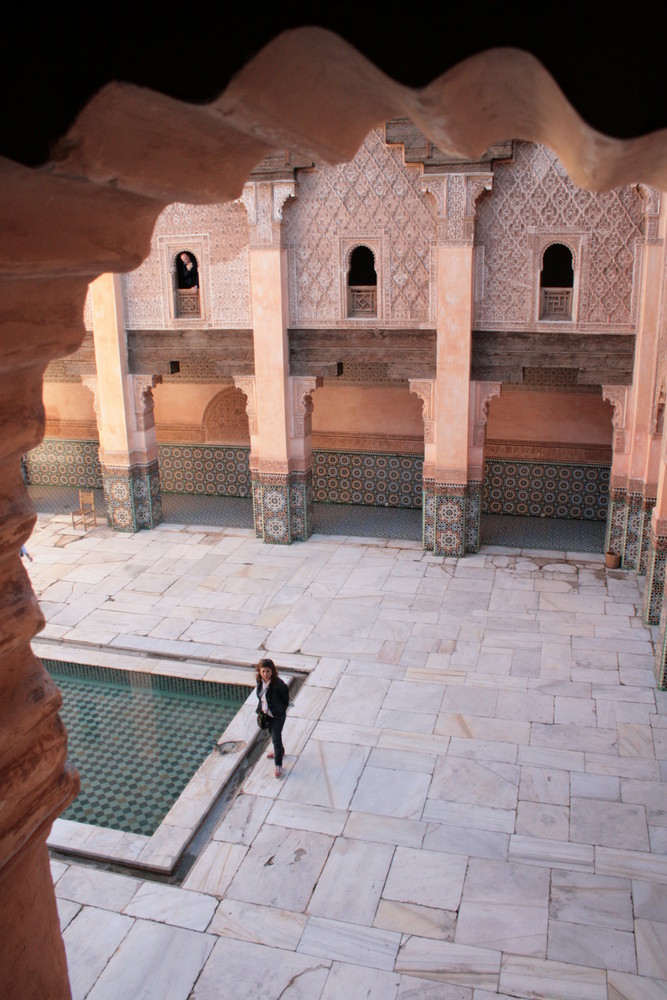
[{"xmin": 5, "ymin": 8, "xmax": 667, "ymax": 165}]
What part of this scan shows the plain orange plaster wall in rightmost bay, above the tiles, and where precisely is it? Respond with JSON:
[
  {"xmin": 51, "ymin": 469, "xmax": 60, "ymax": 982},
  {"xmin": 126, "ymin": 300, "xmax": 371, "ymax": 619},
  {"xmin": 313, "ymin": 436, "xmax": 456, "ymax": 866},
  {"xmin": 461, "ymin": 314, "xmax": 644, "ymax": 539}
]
[{"xmin": 486, "ymin": 389, "xmax": 612, "ymax": 446}]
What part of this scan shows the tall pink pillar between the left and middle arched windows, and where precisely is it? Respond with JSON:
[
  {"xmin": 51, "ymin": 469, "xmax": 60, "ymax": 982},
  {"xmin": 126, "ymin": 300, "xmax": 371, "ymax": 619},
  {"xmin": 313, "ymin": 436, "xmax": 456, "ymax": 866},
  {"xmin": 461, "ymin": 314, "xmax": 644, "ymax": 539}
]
[{"xmin": 237, "ymin": 181, "xmax": 315, "ymax": 544}]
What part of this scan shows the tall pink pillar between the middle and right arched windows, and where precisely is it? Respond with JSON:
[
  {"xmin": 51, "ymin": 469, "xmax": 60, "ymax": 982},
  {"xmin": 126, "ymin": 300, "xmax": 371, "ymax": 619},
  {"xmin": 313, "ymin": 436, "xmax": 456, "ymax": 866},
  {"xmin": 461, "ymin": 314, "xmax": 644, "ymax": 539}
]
[{"xmin": 422, "ymin": 173, "xmax": 493, "ymax": 556}]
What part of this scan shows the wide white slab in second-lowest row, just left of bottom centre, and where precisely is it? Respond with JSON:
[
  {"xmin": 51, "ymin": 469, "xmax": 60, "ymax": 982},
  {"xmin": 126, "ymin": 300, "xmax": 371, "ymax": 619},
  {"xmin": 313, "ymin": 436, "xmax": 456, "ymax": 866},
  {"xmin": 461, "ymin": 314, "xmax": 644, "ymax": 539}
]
[{"xmin": 297, "ymin": 917, "xmax": 401, "ymax": 972}]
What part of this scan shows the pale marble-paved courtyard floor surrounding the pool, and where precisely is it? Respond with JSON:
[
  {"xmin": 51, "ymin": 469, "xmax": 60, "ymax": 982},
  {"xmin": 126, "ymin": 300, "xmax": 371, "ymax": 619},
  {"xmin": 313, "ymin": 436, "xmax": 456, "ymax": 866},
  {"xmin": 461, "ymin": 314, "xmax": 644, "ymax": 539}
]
[{"xmin": 26, "ymin": 515, "xmax": 667, "ymax": 1000}]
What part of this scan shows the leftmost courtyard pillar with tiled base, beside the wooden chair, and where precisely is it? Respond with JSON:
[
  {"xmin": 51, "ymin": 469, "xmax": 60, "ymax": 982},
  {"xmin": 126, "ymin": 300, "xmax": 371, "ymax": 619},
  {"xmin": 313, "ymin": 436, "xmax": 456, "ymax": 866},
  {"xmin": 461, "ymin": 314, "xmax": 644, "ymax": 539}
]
[{"xmin": 85, "ymin": 274, "xmax": 162, "ymax": 531}]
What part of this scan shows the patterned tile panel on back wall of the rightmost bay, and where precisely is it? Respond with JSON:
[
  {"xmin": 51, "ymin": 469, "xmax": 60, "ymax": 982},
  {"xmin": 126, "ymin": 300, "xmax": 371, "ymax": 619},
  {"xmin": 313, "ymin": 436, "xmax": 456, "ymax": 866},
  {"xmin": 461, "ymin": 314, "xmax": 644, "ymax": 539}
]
[{"xmin": 482, "ymin": 458, "xmax": 610, "ymax": 521}]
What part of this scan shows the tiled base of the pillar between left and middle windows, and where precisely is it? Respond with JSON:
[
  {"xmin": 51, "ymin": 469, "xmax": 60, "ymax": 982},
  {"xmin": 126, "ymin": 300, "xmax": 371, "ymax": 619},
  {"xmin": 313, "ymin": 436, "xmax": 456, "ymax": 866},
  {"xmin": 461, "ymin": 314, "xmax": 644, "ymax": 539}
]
[{"xmin": 252, "ymin": 470, "xmax": 313, "ymax": 545}]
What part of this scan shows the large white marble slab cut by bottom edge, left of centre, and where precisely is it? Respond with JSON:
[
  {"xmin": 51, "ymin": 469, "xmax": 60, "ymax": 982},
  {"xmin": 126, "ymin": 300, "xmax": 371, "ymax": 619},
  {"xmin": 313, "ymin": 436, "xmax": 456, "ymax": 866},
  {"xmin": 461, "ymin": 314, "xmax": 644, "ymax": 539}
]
[{"xmin": 189, "ymin": 937, "xmax": 331, "ymax": 1000}]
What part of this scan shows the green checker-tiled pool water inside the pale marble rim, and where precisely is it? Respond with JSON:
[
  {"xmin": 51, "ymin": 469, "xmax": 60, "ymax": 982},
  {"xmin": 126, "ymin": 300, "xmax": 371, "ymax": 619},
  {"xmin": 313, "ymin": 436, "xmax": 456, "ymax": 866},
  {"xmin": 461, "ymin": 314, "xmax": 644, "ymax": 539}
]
[{"xmin": 43, "ymin": 659, "xmax": 252, "ymax": 837}]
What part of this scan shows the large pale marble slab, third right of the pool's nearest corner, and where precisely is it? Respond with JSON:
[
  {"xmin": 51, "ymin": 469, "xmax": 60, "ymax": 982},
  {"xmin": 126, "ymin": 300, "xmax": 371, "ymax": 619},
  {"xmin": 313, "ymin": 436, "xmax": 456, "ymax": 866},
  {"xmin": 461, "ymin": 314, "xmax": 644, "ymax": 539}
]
[{"xmin": 308, "ymin": 837, "xmax": 394, "ymax": 926}]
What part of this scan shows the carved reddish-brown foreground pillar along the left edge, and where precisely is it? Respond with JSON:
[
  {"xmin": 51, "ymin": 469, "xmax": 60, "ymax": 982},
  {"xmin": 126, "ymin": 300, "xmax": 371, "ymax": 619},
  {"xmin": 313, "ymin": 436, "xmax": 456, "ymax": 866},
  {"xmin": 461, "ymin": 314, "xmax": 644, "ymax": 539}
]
[{"xmin": 0, "ymin": 276, "xmax": 87, "ymax": 1000}]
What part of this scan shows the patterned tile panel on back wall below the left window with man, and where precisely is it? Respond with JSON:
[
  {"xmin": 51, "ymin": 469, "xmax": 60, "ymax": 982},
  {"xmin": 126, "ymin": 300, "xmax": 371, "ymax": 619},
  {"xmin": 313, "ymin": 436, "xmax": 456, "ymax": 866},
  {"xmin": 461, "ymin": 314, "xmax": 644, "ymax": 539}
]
[{"xmin": 158, "ymin": 444, "xmax": 252, "ymax": 497}]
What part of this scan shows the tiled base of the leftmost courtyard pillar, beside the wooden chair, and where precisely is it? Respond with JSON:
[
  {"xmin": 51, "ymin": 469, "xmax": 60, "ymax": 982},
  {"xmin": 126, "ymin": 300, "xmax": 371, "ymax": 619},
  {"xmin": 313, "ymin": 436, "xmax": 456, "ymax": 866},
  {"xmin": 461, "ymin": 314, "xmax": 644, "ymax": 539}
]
[{"xmin": 102, "ymin": 462, "xmax": 162, "ymax": 531}]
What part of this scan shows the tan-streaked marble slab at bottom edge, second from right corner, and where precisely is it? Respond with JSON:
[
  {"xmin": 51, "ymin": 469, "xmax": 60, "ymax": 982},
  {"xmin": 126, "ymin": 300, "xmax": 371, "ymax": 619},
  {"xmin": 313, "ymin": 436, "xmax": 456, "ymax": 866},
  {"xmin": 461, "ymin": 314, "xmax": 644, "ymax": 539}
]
[{"xmin": 500, "ymin": 955, "xmax": 607, "ymax": 1000}]
